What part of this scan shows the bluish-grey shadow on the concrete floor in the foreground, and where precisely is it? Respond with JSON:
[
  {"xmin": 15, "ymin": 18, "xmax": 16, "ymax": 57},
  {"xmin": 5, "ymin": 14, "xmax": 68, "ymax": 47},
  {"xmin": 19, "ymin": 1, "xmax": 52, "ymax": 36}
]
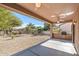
[{"xmin": 12, "ymin": 45, "xmax": 74, "ymax": 56}]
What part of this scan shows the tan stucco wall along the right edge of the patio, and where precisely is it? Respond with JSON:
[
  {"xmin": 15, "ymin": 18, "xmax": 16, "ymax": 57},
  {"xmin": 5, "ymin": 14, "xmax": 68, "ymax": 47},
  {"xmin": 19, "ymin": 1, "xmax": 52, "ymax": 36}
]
[{"xmin": 73, "ymin": 8, "xmax": 79, "ymax": 54}]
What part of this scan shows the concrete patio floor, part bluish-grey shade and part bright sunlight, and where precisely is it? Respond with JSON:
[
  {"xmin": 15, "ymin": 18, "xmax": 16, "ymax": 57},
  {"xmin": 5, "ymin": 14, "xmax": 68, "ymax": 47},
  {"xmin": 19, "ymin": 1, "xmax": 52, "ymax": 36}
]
[{"xmin": 13, "ymin": 39, "xmax": 76, "ymax": 56}]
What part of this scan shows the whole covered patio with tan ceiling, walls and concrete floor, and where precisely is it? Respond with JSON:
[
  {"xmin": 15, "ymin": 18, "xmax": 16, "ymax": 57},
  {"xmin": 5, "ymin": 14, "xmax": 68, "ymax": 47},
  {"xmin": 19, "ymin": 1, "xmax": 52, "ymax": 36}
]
[{"xmin": 0, "ymin": 3, "xmax": 79, "ymax": 56}]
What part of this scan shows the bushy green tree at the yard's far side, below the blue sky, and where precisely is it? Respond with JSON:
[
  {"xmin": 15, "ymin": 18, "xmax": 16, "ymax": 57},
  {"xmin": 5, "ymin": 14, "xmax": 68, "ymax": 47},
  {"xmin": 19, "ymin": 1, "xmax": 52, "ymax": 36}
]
[{"xmin": 26, "ymin": 23, "xmax": 43, "ymax": 35}]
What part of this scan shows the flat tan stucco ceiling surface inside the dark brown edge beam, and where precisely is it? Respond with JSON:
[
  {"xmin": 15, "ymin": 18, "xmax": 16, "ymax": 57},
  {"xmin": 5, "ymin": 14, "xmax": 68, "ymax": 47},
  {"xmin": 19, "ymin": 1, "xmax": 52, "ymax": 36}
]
[{"xmin": 19, "ymin": 3, "xmax": 78, "ymax": 22}]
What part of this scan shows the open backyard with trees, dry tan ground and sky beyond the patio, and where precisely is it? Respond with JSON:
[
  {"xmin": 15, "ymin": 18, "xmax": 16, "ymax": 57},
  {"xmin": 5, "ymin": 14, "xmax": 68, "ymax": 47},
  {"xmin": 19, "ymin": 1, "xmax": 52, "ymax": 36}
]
[{"xmin": 0, "ymin": 7, "xmax": 50, "ymax": 56}]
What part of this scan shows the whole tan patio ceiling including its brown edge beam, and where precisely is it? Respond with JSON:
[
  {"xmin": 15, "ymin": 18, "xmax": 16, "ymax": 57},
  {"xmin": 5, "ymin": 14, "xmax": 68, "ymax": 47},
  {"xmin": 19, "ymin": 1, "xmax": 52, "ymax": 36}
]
[{"xmin": 0, "ymin": 3, "xmax": 79, "ymax": 23}]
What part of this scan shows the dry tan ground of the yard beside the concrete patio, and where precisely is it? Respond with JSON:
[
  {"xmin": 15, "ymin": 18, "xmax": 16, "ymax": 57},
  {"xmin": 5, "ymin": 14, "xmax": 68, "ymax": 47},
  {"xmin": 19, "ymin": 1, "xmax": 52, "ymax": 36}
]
[{"xmin": 0, "ymin": 34, "xmax": 49, "ymax": 56}]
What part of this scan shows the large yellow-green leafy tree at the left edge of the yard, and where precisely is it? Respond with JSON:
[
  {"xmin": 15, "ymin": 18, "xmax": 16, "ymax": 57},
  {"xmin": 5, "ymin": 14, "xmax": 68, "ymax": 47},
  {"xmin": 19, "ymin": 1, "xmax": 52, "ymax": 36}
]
[{"xmin": 0, "ymin": 7, "xmax": 22, "ymax": 38}]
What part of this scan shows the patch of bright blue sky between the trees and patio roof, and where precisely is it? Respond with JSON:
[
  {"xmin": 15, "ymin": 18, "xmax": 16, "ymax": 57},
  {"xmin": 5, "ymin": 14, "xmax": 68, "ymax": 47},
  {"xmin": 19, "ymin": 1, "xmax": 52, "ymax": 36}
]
[{"xmin": 13, "ymin": 12, "xmax": 44, "ymax": 26}]
